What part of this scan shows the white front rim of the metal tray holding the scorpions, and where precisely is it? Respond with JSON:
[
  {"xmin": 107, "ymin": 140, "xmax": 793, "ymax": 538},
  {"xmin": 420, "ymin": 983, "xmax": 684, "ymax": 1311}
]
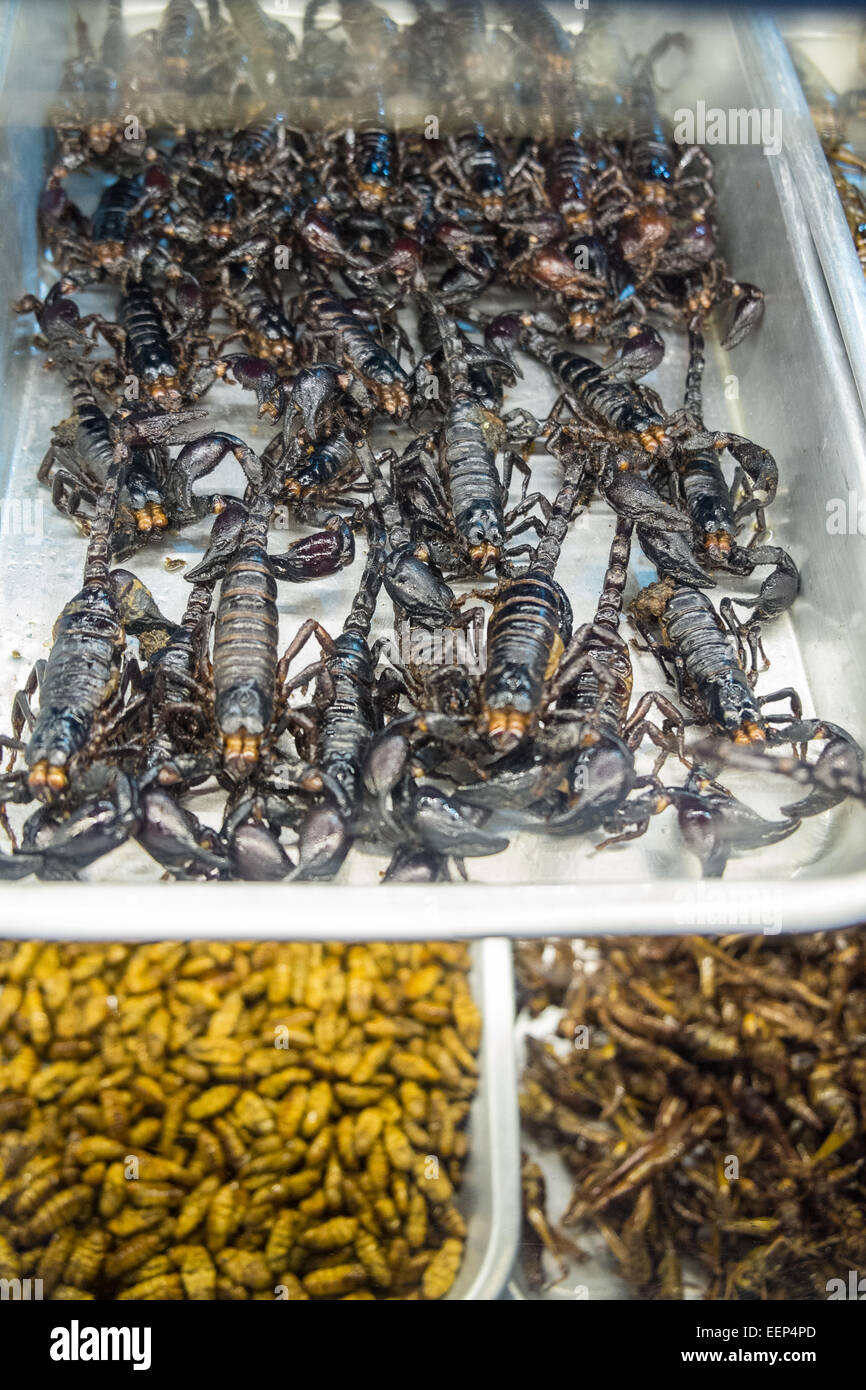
[{"xmin": 0, "ymin": 870, "xmax": 866, "ymax": 941}]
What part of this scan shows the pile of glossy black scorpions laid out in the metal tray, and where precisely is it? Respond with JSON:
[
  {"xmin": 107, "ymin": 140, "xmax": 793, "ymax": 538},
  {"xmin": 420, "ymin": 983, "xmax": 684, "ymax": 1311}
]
[{"xmin": 0, "ymin": 0, "xmax": 866, "ymax": 881}]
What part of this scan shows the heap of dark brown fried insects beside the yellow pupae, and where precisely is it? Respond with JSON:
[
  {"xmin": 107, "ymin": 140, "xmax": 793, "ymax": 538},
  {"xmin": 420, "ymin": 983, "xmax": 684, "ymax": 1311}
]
[{"xmin": 518, "ymin": 929, "xmax": 866, "ymax": 1301}]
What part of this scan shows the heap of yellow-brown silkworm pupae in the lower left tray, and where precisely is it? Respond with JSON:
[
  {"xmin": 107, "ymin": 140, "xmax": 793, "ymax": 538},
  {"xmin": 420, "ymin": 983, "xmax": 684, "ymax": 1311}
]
[{"xmin": 0, "ymin": 941, "xmax": 481, "ymax": 1300}]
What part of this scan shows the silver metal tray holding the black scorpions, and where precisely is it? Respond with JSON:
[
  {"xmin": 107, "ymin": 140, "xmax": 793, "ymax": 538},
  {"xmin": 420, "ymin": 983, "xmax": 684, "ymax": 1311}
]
[{"xmin": 0, "ymin": 0, "xmax": 866, "ymax": 940}]
